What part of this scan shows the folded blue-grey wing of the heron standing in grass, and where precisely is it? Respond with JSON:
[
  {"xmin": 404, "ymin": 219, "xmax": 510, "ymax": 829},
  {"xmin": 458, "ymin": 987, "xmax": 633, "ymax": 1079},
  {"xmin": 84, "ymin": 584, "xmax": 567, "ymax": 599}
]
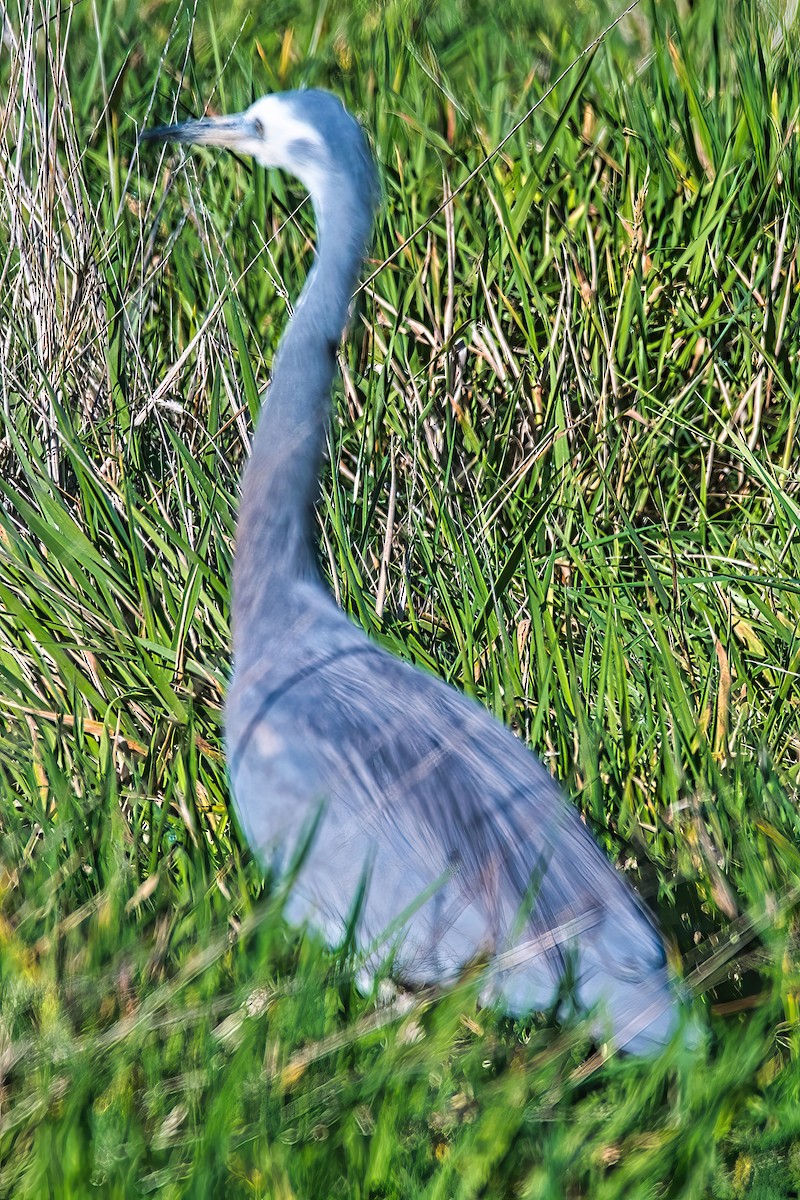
[{"xmin": 221, "ymin": 623, "xmax": 664, "ymax": 1032}]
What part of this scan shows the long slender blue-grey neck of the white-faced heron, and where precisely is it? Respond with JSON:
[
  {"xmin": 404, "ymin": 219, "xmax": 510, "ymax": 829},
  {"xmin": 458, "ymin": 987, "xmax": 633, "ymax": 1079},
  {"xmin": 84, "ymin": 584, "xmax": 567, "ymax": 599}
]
[{"xmin": 233, "ymin": 180, "xmax": 372, "ymax": 659}]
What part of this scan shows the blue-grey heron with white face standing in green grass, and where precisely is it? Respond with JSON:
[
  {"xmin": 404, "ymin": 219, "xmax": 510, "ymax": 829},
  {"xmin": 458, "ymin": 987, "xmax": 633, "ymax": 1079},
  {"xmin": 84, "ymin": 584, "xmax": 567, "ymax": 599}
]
[{"xmin": 148, "ymin": 89, "xmax": 686, "ymax": 1056}]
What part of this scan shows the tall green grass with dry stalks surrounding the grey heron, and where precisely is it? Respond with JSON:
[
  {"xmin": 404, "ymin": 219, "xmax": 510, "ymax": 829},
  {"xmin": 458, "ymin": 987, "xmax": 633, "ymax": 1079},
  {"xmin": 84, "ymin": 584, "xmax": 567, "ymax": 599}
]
[{"xmin": 0, "ymin": 0, "xmax": 800, "ymax": 1200}]
